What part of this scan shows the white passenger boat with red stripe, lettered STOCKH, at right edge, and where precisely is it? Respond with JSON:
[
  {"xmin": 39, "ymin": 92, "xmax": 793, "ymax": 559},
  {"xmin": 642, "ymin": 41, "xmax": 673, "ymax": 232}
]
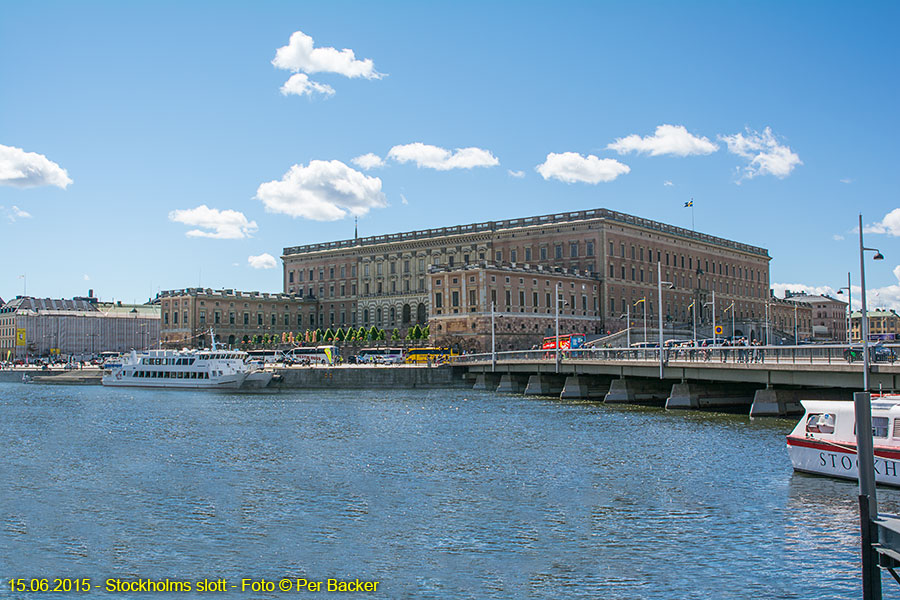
[{"xmin": 787, "ymin": 394, "xmax": 900, "ymax": 487}]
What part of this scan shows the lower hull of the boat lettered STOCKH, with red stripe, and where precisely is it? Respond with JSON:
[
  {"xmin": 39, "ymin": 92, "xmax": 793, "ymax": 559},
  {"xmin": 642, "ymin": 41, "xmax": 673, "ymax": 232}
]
[{"xmin": 787, "ymin": 436, "xmax": 900, "ymax": 487}]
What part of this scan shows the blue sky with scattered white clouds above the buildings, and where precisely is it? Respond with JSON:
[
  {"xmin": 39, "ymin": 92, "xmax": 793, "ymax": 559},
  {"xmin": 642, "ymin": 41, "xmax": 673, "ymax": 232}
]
[{"xmin": 0, "ymin": 1, "xmax": 900, "ymax": 309}]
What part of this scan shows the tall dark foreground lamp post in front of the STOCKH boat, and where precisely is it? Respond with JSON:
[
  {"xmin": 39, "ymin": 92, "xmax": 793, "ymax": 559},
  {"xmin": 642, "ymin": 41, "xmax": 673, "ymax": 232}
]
[{"xmin": 853, "ymin": 214, "xmax": 884, "ymax": 600}]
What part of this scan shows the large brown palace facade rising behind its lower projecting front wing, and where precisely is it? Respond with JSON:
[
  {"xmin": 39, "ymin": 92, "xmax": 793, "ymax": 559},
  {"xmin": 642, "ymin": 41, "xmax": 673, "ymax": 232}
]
[{"xmin": 282, "ymin": 209, "xmax": 770, "ymax": 346}]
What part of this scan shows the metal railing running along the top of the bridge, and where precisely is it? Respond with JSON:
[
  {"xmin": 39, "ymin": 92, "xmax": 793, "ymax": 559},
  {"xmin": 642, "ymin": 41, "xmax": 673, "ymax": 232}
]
[{"xmin": 452, "ymin": 344, "xmax": 900, "ymax": 366}]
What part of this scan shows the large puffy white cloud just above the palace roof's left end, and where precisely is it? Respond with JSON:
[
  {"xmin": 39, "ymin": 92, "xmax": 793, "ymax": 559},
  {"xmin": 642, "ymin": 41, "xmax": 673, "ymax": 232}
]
[{"xmin": 256, "ymin": 160, "xmax": 387, "ymax": 221}]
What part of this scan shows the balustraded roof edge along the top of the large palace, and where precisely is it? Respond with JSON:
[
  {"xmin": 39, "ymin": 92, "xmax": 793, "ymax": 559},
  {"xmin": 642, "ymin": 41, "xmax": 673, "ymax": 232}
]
[{"xmin": 283, "ymin": 208, "xmax": 769, "ymax": 257}]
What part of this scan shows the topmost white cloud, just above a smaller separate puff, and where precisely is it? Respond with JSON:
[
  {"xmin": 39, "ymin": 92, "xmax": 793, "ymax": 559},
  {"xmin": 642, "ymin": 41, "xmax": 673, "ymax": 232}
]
[{"xmin": 272, "ymin": 31, "xmax": 383, "ymax": 79}]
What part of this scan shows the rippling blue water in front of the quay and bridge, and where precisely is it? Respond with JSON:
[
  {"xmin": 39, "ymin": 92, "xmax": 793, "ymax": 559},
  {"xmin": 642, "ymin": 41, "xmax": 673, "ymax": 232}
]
[{"xmin": 0, "ymin": 384, "xmax": 900, "ymax": 599}]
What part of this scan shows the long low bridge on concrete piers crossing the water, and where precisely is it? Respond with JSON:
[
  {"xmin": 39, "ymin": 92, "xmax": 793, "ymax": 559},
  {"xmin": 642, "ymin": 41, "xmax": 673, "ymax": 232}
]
[{"xmin": 453, "ymin": 345, "xmax": 900, "ymax": 416}]
